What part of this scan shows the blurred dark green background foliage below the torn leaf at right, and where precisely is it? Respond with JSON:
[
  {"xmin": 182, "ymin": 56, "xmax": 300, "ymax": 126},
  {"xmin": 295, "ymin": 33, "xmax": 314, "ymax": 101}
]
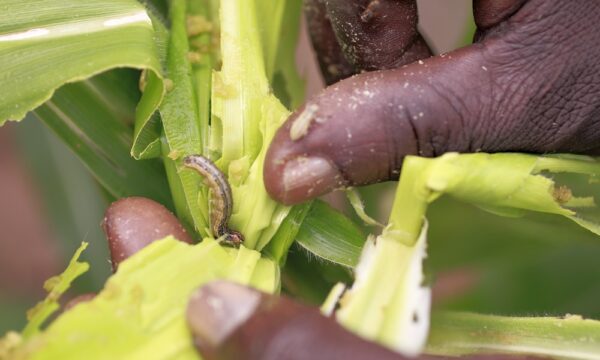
[{"xmin": 429, "ymin": 199, "xmax": 600, "ymax": 318}]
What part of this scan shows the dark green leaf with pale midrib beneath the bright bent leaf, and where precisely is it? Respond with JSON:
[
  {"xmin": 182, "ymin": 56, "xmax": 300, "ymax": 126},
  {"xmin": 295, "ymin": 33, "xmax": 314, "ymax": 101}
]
[{"xmin": 35, "ymin": 79, "xmax": 172, "ymax": 208}]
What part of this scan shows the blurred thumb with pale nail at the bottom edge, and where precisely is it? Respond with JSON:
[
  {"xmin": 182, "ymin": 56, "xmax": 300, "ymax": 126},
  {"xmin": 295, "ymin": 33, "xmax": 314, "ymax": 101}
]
[{"xmin": 186, "ymin": 282, "xmax": 401, "ymax": 360}]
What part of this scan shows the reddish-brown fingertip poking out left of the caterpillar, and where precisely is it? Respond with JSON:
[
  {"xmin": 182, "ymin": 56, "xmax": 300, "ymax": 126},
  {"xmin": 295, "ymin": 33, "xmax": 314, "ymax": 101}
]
[{"xmin": 102, "ymin": 197, "xmax": 193, "ymax": 270}]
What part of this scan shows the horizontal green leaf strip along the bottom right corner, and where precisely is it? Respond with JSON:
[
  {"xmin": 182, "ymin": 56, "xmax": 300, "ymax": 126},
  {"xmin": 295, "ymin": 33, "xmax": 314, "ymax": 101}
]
[{"xmin": 426, "ymin": 312, "xmax": 600, "ymax": 359}]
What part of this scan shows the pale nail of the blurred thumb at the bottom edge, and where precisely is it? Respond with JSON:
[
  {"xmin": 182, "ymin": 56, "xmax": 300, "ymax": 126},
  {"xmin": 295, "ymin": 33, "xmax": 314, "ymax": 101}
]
[{"xmin": 186, "ymin": 281, "xmax": 261, "ymax": 350}]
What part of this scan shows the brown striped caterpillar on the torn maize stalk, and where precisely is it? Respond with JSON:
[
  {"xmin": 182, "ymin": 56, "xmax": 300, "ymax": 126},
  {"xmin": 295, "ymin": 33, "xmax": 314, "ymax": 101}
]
[{"xmin": 183, "ymin": 155, "xmax": 244, "ymax": 246}]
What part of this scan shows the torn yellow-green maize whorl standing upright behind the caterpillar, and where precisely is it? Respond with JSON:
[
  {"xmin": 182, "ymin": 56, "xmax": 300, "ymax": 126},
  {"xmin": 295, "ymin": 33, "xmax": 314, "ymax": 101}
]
[{"xmin": 161, "ymin": 0, "xmax": 303, "ymax": 250}]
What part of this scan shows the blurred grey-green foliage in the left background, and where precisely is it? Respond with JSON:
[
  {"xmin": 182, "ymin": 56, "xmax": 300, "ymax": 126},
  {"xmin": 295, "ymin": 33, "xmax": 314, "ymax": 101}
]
[{"xmin": 0, "ymin": 115, "xmax": 111, "ymax": 334}]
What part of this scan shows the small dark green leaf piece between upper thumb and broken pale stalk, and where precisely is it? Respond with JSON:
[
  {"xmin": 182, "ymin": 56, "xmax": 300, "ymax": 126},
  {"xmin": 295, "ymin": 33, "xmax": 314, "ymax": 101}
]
[{"xmin": 296, "ymin": 200, "xmax": 365, "ymax": 267}]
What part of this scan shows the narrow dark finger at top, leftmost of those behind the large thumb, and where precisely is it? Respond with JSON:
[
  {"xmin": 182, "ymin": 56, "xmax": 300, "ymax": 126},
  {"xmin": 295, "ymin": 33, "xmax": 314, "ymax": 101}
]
[{"xmin": 304, "ymin": 0, "xmax": 355, "ymax": 85}]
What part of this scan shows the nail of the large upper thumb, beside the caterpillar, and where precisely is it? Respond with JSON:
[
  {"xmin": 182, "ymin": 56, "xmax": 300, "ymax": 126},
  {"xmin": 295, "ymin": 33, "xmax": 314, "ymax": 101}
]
[{"xmin": 281, "ymin": 156, "xmax": 344, "ymax": 204}]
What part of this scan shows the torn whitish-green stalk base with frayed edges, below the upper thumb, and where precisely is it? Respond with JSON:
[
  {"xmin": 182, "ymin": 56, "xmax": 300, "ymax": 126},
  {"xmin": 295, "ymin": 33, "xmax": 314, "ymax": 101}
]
[{"xmin": 335, "ymin": 227, "xmax": 431, "ymax": 356}]
